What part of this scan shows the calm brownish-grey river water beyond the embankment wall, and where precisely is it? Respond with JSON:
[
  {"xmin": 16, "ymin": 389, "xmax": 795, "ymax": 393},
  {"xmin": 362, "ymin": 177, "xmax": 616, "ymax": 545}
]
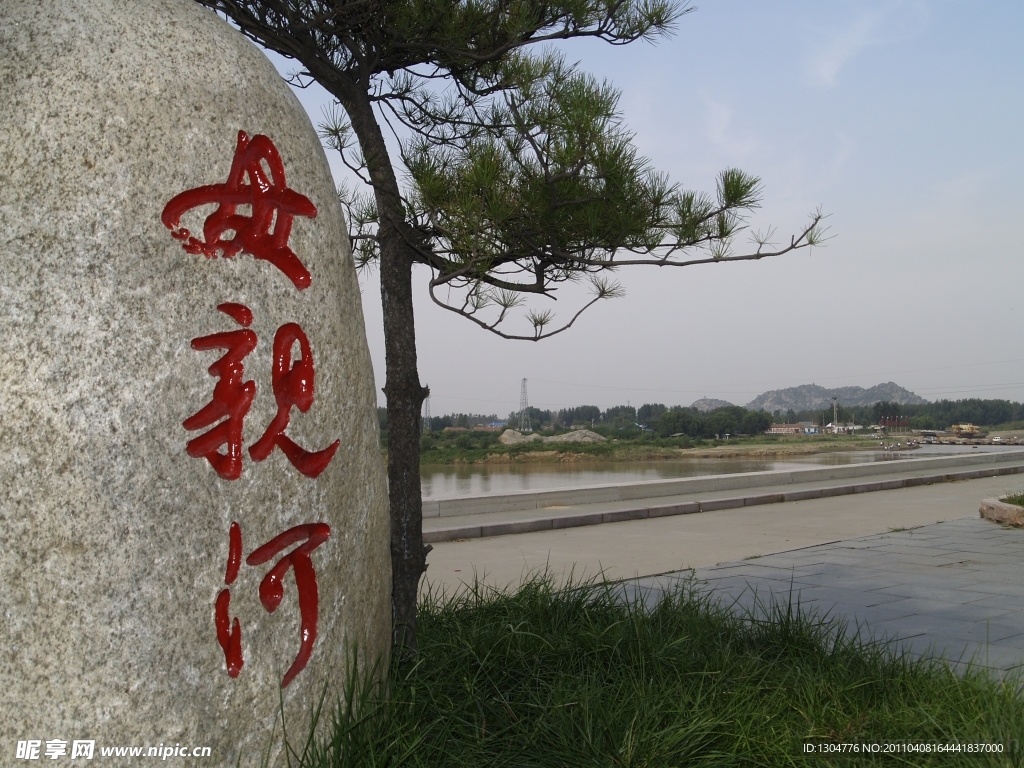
[{"xmin": 420, "ymin": 445, "xmax": 1021, "ymax": 499}]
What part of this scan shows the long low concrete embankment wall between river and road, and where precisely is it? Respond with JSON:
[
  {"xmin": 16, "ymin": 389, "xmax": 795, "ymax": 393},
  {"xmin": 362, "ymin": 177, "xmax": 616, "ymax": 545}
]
[{"xmin": 423, "ymin": 451, "xmax": 1024, "ymax": 517}]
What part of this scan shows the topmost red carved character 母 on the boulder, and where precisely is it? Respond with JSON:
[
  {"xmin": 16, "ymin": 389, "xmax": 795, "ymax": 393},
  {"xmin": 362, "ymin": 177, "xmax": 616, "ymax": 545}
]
[{"xmin": 161, "ymin": 131, "xmax": 316, "ymax": 291}]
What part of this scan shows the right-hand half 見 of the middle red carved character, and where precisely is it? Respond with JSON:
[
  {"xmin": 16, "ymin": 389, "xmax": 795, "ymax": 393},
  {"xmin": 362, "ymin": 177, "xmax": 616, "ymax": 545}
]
[{"xmin": 249, "ymin": 323, "xmax": 340, "ymax": 477}]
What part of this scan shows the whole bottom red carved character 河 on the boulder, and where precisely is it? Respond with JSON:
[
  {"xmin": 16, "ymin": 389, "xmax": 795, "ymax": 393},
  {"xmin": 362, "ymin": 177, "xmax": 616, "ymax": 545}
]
[{"xmin": 214, "ymin": 522, "xmax": 331, "ymax": 688}]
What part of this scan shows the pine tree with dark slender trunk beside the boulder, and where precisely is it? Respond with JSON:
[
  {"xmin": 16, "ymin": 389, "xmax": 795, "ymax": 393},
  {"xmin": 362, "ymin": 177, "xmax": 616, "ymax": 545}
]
[{"xmin": 198, "ymin": 0, "xmax": 822, "ymax": 648}]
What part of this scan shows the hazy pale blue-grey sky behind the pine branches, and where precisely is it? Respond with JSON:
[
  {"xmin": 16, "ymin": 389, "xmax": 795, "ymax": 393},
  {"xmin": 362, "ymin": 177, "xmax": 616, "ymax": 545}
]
[{"xmin": 260, "ymin": 0, "xmax": 1024, "ymax": 417}]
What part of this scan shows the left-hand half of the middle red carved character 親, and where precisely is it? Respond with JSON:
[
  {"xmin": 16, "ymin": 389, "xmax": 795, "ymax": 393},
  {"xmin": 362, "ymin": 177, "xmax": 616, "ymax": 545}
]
[{"xmin": 181, "ymin": 304, "xmax": 256, "ymax": 480}]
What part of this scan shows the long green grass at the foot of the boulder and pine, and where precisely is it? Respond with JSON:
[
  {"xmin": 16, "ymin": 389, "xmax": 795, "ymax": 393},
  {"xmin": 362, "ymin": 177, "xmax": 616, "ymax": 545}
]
[{"xmin": 292, "ymin": 578, "xmax": 1024, "ymax": 768}]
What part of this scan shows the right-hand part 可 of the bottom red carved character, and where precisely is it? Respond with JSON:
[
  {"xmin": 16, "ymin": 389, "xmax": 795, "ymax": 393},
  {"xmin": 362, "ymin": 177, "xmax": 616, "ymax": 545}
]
[{"xmin": 246, "ymin": 522, "xmax": 331, "ymax": 688}]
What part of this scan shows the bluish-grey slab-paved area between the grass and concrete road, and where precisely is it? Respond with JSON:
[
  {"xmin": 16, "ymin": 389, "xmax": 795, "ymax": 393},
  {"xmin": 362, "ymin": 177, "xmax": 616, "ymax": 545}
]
[{"xmin": 629, "ymin": 517, "xmax": 1024, "ymax": 671}]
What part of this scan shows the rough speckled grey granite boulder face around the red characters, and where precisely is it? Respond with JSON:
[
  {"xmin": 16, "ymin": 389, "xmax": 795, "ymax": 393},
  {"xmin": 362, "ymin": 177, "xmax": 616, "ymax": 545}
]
[{"xmin": 0, "ymin": 0, "xmax": 390, "ymax": 766}]
